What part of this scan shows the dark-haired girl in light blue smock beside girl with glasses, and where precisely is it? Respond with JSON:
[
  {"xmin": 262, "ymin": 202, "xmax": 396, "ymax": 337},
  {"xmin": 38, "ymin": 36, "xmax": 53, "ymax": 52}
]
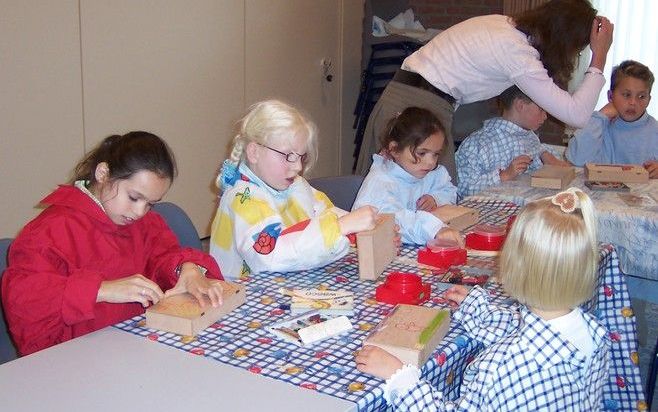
[{"xmin": 354, "ymin": 107, "xmax": 463, "ymax": 245}]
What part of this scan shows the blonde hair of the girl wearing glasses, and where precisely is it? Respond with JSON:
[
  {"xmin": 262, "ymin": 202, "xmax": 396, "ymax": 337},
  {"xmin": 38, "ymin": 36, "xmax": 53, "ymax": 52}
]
[{"xmin": 229, "ymin": 100, "xmax": 318, "ymax": 172}]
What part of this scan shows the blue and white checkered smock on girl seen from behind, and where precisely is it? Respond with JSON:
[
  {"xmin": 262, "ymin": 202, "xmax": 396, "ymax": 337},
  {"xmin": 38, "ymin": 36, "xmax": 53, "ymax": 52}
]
[{"xmin": 389, "ymin": 288, "xmax": 608, "ymax": 412}]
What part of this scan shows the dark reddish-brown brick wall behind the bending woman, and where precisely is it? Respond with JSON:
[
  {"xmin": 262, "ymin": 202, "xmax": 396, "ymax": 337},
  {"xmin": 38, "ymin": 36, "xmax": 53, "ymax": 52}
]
[{"xmin": 409, "ymin": 0, "xmax": 564, "ymax": 144}]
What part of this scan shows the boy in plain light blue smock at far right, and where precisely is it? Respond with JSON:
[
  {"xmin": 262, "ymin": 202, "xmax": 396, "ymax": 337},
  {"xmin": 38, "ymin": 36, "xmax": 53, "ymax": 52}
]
[{"xmin": 566, "ymin": 60, "xmax": 658, "ymax": 179}]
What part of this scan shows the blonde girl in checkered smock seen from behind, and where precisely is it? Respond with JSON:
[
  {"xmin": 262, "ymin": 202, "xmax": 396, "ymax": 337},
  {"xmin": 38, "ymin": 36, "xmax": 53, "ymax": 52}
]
[{"xmin": 356, "ymin": 188, "xmax": 608, "ymax": 411}]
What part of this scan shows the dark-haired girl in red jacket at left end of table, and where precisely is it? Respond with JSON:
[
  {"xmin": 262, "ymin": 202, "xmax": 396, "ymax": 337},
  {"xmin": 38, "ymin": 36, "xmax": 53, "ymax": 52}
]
[{"xmin": 2, "ymin": 132, "xmax": 222, "ymax": 355}]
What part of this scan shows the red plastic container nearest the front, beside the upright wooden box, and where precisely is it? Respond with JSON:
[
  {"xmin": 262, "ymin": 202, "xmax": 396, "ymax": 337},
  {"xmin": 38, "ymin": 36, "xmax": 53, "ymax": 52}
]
[{"xmin": 375, "ymin": 272, "xmax": 432, "ymax": 305}]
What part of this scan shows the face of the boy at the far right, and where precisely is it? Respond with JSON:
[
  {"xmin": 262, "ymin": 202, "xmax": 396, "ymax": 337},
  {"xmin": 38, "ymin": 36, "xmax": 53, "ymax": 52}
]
[{"xmin": 608, "ymin": 76, "xmax": 651, "ymax": 122}]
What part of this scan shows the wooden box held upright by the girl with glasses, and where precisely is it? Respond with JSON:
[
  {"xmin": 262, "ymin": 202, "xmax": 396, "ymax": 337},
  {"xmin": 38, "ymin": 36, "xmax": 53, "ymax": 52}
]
[{"xmin": 356, "ymin": 213, "xmax": 397, "ymax": 280}]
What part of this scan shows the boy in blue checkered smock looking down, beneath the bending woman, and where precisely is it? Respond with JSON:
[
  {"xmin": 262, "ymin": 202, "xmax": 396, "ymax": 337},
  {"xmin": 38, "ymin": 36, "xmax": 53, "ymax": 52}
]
[{"xmin": 456, "ymin": 86, "xmax": 567, "ymax": 197}]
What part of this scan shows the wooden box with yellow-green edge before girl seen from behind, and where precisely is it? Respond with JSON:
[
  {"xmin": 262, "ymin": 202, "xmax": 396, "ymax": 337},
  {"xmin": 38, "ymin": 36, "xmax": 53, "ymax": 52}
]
[{"xmin": 363, "ymin": 305, "xmax": 450, "ymax": 368}]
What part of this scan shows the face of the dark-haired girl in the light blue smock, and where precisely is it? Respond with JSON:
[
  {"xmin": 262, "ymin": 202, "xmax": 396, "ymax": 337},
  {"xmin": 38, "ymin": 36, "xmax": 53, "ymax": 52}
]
[{"xmin": 388, "ymin": 132, "xmax": 445, "ymax": 179}]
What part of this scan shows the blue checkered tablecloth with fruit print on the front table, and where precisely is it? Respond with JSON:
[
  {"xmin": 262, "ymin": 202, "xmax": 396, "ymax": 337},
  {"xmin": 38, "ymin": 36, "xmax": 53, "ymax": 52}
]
[{"xmin": 115, "ymin": 200, "xmax": 643, "ymax": 411}]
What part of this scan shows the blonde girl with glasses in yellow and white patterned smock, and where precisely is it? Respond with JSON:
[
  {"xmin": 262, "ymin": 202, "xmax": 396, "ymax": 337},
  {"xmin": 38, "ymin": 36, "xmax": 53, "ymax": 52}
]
[{"xmin": 210, "ymin": 100, "xmax": 377, "ymax": 278}]
